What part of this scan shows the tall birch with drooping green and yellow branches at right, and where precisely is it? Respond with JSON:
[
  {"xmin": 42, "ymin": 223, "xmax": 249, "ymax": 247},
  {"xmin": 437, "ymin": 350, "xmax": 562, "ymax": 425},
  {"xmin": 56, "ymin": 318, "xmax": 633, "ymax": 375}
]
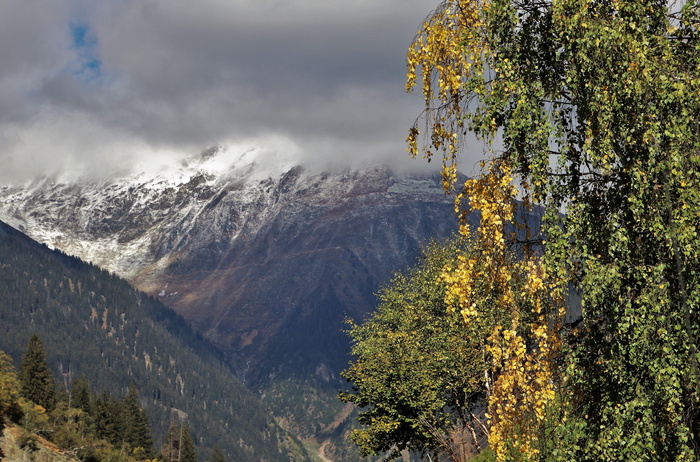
[{"xmin": 408, "ymin": 0, "xmax": 700, "ymax": 461}]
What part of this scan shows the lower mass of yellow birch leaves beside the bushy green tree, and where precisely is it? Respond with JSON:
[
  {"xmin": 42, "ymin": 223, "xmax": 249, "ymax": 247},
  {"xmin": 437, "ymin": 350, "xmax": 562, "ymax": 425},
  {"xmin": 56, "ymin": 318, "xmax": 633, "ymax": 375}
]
[{"xmin": 442, "ymin": 160, "xmax": 563, "ymax": 460}]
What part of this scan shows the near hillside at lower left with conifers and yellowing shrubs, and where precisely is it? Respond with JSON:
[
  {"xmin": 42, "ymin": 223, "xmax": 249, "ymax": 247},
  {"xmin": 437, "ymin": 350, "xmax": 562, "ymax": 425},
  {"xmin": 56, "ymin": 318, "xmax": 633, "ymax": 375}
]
[{"xmin": 0, "ymin": 334, "xmax": 159, "ymax": 462}]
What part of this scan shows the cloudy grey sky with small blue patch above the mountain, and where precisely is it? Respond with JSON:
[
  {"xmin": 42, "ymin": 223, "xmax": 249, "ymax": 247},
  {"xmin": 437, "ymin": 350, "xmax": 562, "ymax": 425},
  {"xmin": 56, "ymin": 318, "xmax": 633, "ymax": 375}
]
[{"xmin": 0, "ymin": 0, "xmax": 476, "ymax": 182}]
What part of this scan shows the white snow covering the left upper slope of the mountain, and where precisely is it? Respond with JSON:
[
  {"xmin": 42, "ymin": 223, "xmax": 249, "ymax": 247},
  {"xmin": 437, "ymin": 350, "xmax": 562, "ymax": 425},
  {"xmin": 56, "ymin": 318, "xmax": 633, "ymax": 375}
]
[{"xmin": 0, "ymin": 148, "xmax": 296, "ymax": 279}]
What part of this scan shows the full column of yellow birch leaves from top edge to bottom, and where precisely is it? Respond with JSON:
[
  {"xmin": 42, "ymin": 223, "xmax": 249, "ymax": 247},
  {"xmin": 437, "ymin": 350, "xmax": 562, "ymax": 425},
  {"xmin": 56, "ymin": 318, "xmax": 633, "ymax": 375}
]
[{"xmin": 407, "ymin": 0, "xmax": 563, "ymax": 461}]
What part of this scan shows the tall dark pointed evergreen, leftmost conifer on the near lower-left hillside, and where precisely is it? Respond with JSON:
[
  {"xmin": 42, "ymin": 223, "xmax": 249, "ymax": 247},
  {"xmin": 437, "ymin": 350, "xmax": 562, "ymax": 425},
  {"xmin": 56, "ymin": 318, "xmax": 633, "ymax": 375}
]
[{"xmin": 19, "ymin": 334, "xmax": 56, "ymax": 411}]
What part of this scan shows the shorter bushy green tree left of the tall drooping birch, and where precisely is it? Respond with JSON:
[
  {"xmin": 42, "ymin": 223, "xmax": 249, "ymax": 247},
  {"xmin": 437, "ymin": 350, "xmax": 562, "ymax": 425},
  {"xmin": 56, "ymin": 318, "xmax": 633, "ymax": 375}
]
[{"xmin": 340, "ymin": 240, "xmax": 508, "ymax": 461}]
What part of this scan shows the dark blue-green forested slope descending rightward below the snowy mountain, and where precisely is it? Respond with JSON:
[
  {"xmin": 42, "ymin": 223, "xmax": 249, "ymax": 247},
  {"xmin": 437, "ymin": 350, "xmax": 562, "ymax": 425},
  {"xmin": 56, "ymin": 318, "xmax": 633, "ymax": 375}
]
[{"xmin": 0, "ymin": 223, "xmax": 307, "ymax": 461}]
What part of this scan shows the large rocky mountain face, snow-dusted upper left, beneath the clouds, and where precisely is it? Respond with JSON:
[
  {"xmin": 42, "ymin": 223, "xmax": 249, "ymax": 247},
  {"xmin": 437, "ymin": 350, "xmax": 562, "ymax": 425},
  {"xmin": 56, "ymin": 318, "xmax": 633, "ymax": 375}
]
[{"xmin": 0, "ymin": 149, "xmax": 464, "ymax": 381}]
